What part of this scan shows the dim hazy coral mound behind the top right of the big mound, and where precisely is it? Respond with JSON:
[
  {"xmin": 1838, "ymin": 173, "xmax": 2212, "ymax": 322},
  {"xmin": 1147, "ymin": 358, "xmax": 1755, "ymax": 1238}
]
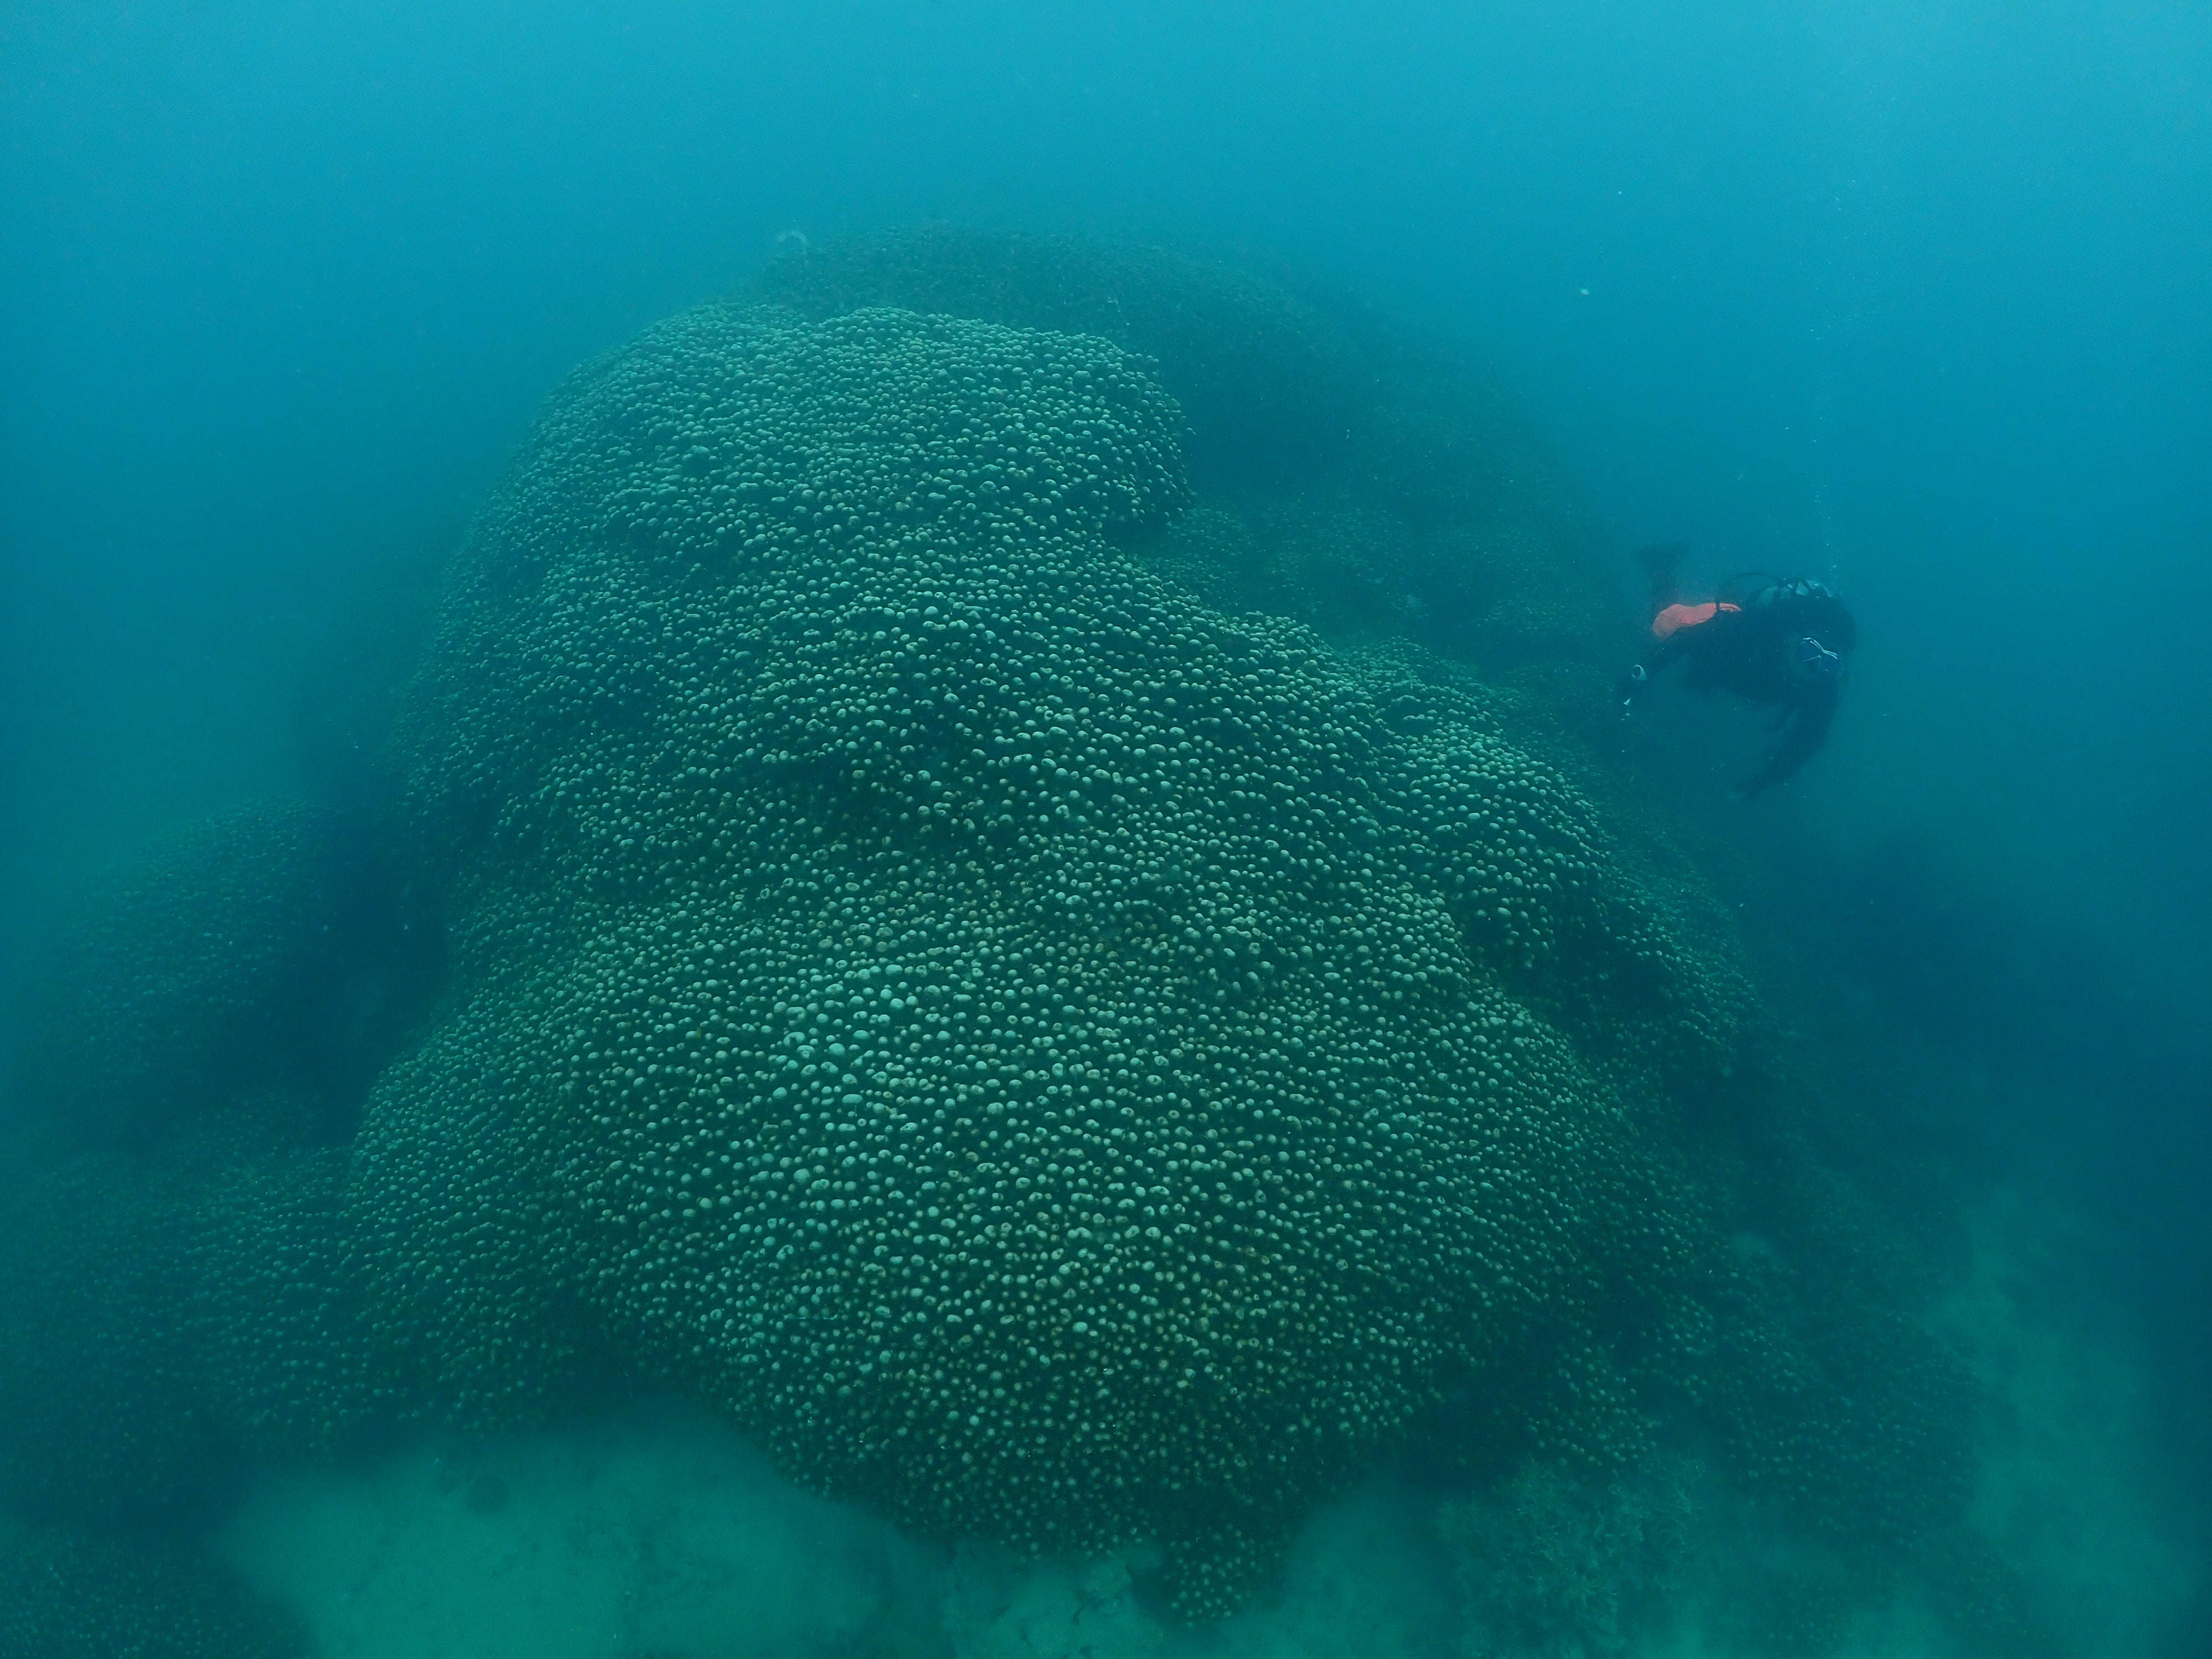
[{"xmin": 752, "ymin": 223, "xmax": 1628, "ymax": 677}]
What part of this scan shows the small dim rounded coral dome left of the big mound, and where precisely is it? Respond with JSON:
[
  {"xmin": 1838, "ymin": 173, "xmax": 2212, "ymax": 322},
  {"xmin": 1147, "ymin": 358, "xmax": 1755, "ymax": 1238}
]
[{"xmin": 11, "ymin": 799, "xmax": 436, "ymax": 1155}]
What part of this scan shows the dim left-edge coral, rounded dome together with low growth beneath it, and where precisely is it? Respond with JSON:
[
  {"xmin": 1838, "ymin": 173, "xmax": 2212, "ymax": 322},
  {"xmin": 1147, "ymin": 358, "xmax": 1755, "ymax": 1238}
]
[{"xmin": 0, "ymin": 801, "xmax": 420, "ymax": 1526}]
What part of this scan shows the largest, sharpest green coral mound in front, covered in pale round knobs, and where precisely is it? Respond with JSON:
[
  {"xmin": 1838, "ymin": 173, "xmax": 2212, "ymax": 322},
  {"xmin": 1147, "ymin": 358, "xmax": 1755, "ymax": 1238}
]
[{"xmin": 349, "ymin": 305, "xmax": 1728, "ymax": 1608}]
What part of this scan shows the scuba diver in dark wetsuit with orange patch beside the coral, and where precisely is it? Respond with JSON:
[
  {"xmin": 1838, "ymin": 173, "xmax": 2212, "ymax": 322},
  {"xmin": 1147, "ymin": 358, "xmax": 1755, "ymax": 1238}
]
[{"xmin": 1619, "ymin": 544, "xmax": 1858, "ymax": 799}]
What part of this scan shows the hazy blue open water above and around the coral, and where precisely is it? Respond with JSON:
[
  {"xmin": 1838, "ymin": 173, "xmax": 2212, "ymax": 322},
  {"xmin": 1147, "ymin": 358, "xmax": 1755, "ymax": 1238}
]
[{"xmin": 0, "ymin": 0, "xmax": 2212, "ymax": 1652}]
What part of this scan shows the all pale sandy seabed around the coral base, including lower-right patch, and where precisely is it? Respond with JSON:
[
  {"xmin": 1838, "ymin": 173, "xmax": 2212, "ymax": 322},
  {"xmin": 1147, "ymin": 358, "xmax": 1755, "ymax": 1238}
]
[{"xmin": 219, "ymin": 1203, "xmax": 2203, "ymax": 1659}]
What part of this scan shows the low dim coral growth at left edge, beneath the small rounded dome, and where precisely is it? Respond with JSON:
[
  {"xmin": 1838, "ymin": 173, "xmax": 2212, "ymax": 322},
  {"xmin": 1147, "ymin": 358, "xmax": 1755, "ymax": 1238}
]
[{"xmin": 0, "ymin": 1133, "xmax": 372, "ymax": 1526}]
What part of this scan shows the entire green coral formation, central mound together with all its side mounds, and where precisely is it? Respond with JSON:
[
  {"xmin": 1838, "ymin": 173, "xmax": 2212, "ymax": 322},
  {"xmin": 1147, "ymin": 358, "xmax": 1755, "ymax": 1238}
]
[{"xmin": 0, "ymin": 230, "xmax": 2008, "ymax": 1624}]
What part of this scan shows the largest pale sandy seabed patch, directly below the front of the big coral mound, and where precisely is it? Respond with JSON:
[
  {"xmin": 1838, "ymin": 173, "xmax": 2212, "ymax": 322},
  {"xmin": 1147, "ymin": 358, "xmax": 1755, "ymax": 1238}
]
[{"xmin": 221, "ymin": 1411, "xmax": 1449, "ymax": 1659}]
